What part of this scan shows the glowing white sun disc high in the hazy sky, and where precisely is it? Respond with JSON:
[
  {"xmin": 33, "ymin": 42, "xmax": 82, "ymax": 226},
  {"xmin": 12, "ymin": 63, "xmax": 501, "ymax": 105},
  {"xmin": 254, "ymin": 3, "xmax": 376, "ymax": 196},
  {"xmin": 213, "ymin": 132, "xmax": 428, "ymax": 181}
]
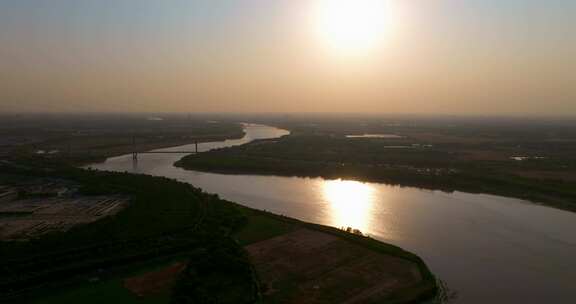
[{"xmin": 314, "ymin": 0, "xmax": 389, "ymax": 55}]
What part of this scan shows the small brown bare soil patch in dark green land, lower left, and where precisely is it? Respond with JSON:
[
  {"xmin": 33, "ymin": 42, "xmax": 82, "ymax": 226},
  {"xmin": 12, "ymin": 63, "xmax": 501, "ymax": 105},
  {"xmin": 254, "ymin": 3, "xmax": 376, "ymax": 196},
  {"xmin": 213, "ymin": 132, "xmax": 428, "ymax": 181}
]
[{"xmin": 124, "ymin": 262, "xmax": 186, "ymax": 297}]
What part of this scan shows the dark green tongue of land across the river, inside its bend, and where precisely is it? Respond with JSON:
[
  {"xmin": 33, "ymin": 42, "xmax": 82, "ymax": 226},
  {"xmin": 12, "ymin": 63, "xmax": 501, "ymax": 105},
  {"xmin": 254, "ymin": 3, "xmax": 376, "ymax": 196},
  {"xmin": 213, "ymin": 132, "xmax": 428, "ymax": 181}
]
[{"xmin": 176, "ymin": 133, "xmax": 576, "ymax": 211}]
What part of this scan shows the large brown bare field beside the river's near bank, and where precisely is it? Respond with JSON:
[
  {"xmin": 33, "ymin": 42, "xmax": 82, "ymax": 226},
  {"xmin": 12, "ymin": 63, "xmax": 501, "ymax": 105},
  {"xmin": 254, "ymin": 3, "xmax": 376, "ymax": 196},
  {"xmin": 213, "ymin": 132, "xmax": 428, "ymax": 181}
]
[{"xmin": 246, "ymin": 229, "xmax": 422, "ymax": 304}]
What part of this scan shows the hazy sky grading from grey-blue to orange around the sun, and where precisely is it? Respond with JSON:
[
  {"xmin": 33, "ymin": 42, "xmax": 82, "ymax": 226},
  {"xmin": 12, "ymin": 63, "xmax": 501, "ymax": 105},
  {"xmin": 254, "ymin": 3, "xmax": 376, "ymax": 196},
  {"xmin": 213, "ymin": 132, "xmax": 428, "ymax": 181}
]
[{"xmin": 0, "ymin": 0, "xmax": 576, "ymax": 115}]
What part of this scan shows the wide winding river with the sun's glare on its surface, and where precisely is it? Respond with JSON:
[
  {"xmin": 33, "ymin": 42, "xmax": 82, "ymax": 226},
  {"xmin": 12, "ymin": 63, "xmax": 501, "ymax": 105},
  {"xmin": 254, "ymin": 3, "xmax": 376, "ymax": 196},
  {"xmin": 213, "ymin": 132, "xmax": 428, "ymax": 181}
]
[{"xmin": 90, "ymin": 125, "xmax": 576, "ymax": 304}]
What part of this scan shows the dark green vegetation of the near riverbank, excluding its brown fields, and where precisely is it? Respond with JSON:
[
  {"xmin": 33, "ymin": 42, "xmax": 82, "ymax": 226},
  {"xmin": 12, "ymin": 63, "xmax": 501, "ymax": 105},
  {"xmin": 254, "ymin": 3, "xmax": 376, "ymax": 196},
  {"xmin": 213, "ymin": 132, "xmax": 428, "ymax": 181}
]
[{"xmin": 0, "ymin": 163, "xmax": 436, "ymax": 303}]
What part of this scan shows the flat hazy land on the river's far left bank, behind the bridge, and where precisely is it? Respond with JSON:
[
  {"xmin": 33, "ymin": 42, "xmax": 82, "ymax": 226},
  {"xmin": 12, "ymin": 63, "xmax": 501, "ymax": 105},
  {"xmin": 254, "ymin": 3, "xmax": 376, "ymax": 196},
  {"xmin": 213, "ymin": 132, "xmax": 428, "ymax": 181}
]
[{"xmin": 0, "ymin": 116, "xmax": 245, "ymax": 166}]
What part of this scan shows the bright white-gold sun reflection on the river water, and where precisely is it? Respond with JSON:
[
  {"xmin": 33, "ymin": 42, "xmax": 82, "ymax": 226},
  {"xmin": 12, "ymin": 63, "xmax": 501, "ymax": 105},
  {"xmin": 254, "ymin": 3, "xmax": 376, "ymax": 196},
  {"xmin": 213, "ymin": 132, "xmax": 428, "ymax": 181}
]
[{"xmin": 322, "ymin": 180, "xmax": 374, "ymax": 232}]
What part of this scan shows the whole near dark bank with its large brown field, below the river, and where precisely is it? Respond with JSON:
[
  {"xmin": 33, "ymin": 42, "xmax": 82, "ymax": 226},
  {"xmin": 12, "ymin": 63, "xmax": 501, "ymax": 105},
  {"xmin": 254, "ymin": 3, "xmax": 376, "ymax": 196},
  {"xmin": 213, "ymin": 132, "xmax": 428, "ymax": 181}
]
[{"xmin": 0, "ymin": 159, "xmax": 438, "ymax": 304}]
